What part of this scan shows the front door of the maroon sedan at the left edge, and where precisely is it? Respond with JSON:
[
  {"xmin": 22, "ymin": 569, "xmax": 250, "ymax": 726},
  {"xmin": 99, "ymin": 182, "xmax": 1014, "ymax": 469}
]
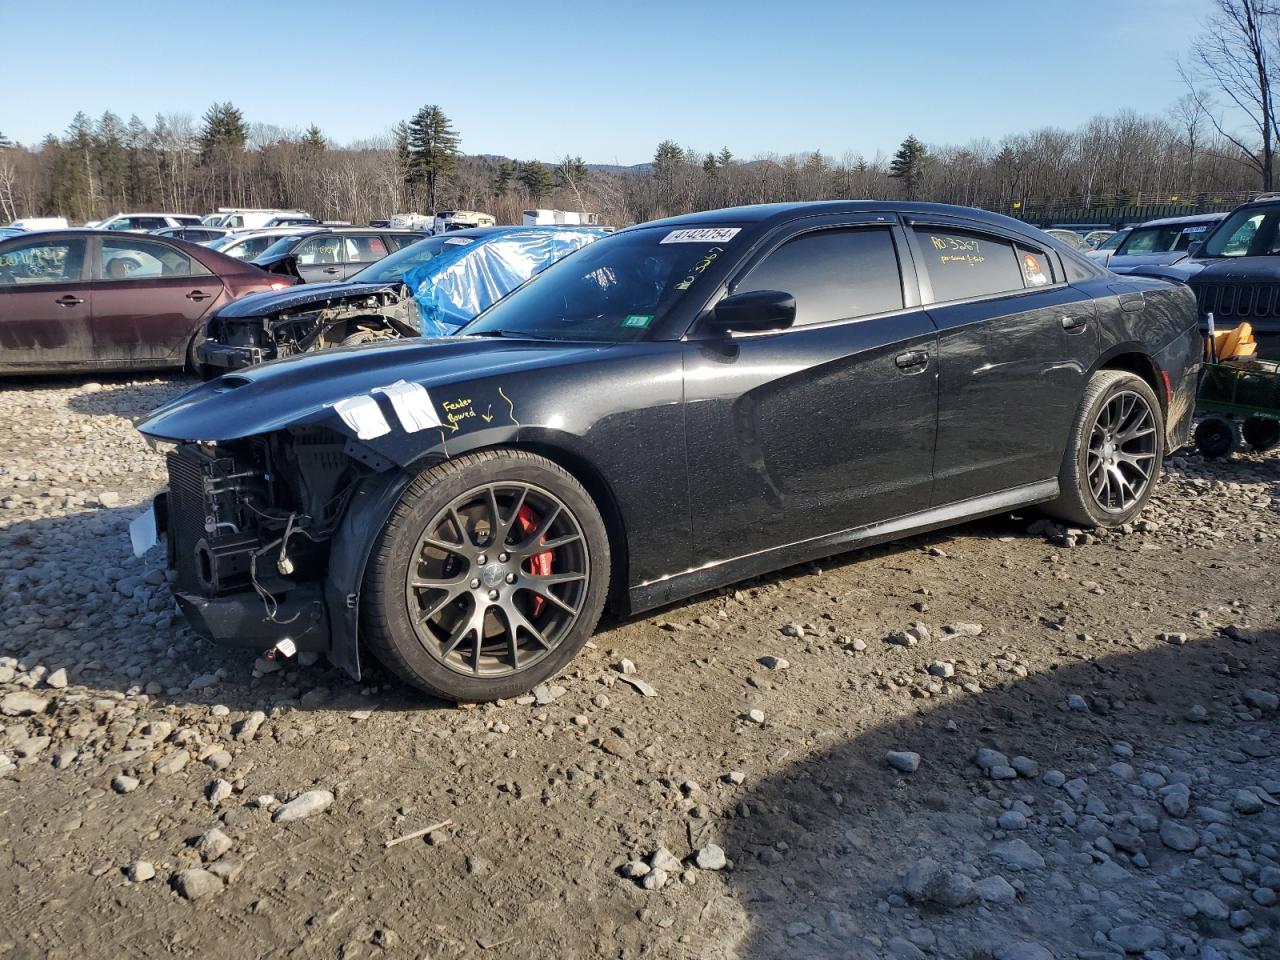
[{"xmin": 0, "ymin": 237, "xmax": 93, "ymax": 370}]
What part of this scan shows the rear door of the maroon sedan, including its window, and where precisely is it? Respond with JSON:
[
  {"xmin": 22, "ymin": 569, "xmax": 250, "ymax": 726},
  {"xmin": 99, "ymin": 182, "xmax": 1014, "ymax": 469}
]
[{"xmin": 92, "ymin": 234, "xmax": 223, "ymax": 365}]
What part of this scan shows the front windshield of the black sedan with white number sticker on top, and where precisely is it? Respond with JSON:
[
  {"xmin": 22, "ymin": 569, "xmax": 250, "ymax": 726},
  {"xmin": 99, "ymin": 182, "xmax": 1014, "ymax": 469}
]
[{"xmin": 460, "ymin": 227, "xmax": 741, "ymax": 343}]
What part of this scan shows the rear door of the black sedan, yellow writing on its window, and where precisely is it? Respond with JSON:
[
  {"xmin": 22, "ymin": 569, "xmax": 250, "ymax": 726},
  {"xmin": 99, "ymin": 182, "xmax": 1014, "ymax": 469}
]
[{"xmin": 908, "ymin": 216, "xmax": 1097, "ymax": 506}]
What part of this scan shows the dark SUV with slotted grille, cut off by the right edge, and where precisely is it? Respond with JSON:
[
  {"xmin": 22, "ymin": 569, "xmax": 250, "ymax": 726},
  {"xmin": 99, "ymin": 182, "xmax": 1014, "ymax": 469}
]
[{"xmin": 1130, "ymin": 195, "xmax": 1280, "ymax": 360}]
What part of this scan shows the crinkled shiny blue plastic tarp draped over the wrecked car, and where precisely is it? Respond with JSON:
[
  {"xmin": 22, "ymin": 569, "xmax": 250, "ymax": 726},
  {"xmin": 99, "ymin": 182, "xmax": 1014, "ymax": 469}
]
[{"xmin": 404, "ymin": 227, "xmax": 607, "ymax": 337}]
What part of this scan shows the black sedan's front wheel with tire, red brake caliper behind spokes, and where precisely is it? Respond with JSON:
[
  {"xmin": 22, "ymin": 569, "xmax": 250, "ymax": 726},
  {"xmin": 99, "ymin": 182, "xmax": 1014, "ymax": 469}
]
[{"xmin": 361, "ymin": 449, "xmax": 611, "ymax": 703}]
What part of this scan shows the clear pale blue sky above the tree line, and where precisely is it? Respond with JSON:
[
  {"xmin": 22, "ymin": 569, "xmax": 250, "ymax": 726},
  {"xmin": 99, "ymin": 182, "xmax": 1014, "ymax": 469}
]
[{"xmin": 0, "ymin": 0, "xmax": 1208, "ymax": 164}]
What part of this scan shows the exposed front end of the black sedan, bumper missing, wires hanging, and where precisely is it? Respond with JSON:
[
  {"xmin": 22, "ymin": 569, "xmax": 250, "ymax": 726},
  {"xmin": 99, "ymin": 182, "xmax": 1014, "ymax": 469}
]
[{"xmin": 155, "ymin": 428, "xmax": 367, "ymax": 654}]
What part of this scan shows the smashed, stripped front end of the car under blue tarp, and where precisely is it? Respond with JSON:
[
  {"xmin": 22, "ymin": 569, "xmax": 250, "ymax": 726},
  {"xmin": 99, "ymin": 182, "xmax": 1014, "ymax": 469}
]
[{"xmin": 196, "ymin": 284, "xmax": 421, "ymax": 378}]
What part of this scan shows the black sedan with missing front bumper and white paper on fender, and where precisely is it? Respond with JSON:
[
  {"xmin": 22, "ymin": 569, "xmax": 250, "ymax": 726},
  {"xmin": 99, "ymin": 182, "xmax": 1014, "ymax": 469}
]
[{"xmin": 134, "ymin": 201, "xmax": 1201, "ymax": 700}]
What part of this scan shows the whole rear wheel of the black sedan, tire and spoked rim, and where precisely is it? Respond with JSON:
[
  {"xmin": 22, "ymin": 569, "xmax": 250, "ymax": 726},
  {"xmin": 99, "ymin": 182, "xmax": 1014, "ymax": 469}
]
[{"xmin": 1043, "ymin": 370, "xmax": 1165, "ymax": 527}]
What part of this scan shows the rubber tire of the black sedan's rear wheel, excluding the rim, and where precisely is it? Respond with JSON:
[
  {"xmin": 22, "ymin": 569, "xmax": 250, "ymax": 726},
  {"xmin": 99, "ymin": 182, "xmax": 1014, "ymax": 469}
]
[{"xmin": 1042, "ymin": 370, "xmax": 1165, "ymax": 527}]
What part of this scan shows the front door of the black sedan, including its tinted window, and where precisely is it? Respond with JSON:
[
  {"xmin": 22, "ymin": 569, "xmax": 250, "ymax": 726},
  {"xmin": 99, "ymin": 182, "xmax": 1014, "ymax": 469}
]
[{"xmin": 684, "ymin": 215, "xmax": 937, "ymax": 566}]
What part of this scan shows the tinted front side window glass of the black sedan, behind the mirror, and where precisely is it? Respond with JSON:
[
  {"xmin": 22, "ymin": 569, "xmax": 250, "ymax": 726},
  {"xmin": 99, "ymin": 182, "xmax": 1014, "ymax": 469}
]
[{"xmin": 733, "ymin": 228, "xmax": 902, "ymax": 326}]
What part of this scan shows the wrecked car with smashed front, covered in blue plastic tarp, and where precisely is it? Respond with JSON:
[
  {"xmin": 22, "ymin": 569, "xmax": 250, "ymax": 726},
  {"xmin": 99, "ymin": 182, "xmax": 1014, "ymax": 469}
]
[{"xmin": 198, "ymin": 227, "xmax": 605, "ymax": 379}]
